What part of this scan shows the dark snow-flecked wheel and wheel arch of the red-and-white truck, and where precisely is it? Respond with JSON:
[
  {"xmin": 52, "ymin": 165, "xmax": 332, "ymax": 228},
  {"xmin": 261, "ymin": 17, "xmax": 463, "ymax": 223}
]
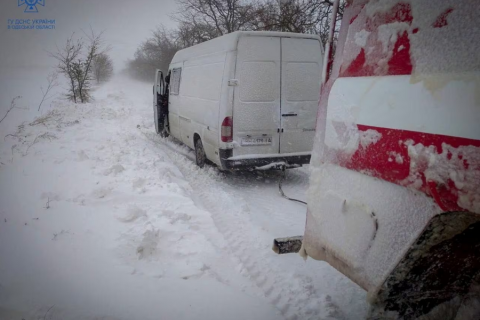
[{"xmin": 372, "ymin": 212, "xmax": 480, "ymax": 319}]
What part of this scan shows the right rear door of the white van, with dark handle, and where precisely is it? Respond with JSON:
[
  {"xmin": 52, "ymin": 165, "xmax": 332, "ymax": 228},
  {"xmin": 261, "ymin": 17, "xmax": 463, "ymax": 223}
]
[{"xmin": 280, "ymin": 38, "xmax": 322, "ymax": 153}]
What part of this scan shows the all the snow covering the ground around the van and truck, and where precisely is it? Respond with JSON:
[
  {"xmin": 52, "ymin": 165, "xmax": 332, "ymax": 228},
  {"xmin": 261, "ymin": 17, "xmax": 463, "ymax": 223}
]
[{"xmin": 0, "ymin": 76, "xmax": 367, "ymax": 320}]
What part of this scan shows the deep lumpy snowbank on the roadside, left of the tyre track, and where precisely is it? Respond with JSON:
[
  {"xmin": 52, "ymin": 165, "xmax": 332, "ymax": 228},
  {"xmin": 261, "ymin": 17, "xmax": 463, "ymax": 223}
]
[{"xmin": 0, "ymin": 75, "xmax": 281, "ymax": 320}]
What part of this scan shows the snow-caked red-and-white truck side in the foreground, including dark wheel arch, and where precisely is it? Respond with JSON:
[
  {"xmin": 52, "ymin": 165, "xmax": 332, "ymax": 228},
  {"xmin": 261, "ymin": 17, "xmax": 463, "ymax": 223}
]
[{"xmin": 301, "ymin": 0, "xmax": 480, "ymax": 319}]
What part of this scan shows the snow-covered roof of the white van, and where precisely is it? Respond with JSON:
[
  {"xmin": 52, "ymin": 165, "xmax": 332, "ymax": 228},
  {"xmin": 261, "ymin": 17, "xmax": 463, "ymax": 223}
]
[{"xmin": 171, "ymin": 31, "xmax": 320, "ymax": 64}]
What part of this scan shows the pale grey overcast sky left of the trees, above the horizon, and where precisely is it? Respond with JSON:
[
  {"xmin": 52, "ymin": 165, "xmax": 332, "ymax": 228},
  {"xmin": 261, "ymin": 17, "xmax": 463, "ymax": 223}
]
[{"xmin": 0, "ymin": 0, "xmax": 176, "ymax": 72}]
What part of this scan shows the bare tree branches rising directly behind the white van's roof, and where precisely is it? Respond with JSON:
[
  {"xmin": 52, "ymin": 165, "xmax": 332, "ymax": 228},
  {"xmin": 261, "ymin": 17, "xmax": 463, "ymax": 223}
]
[{"xmin": 127, "ymin": 0, "xmax": 345, "ymax": 80}]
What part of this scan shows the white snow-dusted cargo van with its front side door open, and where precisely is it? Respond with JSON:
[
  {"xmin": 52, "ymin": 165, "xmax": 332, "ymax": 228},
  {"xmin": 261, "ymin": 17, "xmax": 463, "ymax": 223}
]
[{"xmin": 154, "ymin": 31, "xmax": 323, "ymax": 170}]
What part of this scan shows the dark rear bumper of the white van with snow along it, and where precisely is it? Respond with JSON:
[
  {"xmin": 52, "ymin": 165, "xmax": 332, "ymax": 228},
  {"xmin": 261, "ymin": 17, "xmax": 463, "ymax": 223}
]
[{"xmin": 220, "ymin": 149, "xmax": 311, "ymax": 170}]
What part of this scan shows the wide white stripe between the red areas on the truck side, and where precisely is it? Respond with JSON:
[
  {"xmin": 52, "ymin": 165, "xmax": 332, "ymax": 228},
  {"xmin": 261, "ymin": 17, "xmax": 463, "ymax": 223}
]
[{"xmin": 327, "ymin": 72, "xmax": 480, "ymax": 140}]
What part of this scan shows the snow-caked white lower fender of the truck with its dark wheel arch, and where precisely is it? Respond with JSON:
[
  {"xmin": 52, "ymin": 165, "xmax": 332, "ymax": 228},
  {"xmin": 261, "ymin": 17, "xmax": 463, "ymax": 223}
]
[{"xmin": 300, "ymin": 164, "xmax": 480, "ymax": 319}]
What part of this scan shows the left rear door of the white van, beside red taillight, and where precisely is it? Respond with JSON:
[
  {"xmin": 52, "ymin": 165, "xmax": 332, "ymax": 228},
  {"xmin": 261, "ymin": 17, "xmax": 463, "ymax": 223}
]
[{"xmin": 233, "ymin": 36, "xmax": 281, "ymax": 156}]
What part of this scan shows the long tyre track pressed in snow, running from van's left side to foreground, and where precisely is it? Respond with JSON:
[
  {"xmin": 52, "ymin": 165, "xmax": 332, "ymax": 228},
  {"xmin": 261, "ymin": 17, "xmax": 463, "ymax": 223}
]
[{"xmin": 139, "ymin": 133, "xmax": 341, "ymax": 320}]
